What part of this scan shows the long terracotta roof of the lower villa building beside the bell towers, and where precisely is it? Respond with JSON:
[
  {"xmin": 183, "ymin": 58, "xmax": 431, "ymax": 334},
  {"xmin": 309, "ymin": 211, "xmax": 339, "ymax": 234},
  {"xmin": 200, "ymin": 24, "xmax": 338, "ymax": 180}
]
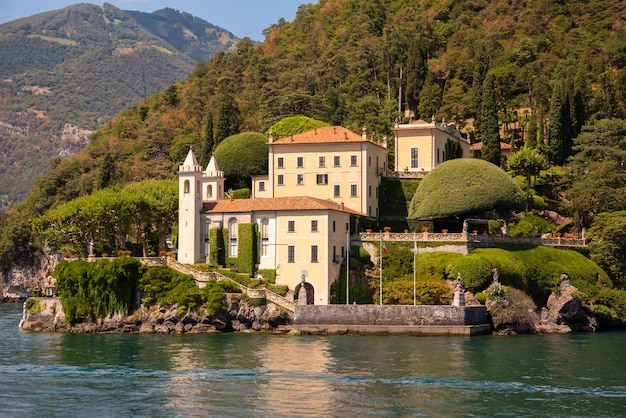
[{"xmin": 202, "ymin": 196, "xmax": 363, "ymax": 215}]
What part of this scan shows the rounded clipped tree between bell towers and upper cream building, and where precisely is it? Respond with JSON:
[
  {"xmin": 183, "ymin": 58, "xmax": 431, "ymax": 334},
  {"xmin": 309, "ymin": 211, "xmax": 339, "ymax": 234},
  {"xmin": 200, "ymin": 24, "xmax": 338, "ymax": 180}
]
[{"xmin": 214, "ymin": 132, "xmax": 267, "ymax": 189}]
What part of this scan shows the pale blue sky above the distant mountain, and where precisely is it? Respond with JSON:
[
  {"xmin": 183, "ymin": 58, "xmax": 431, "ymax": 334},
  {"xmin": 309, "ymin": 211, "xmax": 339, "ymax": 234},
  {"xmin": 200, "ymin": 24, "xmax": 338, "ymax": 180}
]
[{"xmin": 0, "ymin": 0, "xmax": 302, "ymax": 41}]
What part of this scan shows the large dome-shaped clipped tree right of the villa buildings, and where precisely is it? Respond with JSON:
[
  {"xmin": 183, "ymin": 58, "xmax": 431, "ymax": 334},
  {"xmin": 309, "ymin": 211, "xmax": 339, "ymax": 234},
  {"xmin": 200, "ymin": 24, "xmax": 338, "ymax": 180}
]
[{"xmin": 409, "ymin": 158, "xmax": 526, "ymax": 219}]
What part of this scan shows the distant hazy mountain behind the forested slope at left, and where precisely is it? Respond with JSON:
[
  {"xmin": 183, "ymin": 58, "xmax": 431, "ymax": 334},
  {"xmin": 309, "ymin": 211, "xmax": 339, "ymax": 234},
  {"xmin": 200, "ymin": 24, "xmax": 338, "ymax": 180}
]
[{"xmin": 0, "ymin": 3, "xmax": 239, "ymax": 204}]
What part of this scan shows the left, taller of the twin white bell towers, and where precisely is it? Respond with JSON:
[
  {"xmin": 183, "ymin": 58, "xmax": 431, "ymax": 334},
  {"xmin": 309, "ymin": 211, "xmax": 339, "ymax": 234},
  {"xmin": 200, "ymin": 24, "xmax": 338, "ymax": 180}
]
[{"xmin": 178, "ymin": 148, "xmax": 202, "ymax": 264}]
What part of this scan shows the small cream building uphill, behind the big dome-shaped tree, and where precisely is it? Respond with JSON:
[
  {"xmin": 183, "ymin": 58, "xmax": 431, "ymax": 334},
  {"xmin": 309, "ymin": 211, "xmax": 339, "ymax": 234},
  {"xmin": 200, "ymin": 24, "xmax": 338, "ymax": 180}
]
[{"xmin": 392, "ymin": 119, "xmax": 471, "ymax": 173}]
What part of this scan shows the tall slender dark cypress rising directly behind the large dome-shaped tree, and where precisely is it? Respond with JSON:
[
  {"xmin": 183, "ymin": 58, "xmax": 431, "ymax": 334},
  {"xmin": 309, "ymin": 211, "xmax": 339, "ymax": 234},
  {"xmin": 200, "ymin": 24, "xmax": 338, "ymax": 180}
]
[{"xmin": 480, "ymin": 74, "xmax": 500, "ymax": 167}]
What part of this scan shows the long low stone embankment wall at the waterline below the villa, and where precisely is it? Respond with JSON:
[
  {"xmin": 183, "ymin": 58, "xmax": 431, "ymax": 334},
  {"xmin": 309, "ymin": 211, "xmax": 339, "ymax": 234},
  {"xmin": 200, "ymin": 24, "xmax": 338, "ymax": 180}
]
[{"xmin": 294, "ymin": 305, "xmax": 489, "ymax": 328}]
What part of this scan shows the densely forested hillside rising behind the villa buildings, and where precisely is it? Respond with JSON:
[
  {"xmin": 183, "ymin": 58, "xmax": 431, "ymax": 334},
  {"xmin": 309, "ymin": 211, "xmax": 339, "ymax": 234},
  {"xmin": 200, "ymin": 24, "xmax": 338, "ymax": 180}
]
[{"xmin": 0, "ymin": 0, "xmax": 626, "ymax": 284}]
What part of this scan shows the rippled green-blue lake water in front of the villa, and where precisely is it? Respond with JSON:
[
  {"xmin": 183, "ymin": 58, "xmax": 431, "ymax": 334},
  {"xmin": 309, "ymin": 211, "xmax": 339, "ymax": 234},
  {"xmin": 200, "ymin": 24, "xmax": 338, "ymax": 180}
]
[{"xmin": 0, "ymin": 304, "xmax": 626, "ymax": 417}]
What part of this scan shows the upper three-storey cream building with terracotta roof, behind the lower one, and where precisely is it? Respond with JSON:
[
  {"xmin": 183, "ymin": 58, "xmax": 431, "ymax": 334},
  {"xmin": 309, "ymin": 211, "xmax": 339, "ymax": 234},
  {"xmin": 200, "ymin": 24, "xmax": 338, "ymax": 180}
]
[{"xmin": 252, "ymin": 126, "xmax": 388, "ymax": 217}]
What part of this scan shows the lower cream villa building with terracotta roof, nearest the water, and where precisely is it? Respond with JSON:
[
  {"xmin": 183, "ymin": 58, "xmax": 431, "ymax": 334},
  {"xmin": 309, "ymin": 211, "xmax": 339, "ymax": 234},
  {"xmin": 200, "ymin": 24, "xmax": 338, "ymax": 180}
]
[{"xmin": 200, "ymin": 197, "xmax": 356, "ymax": 305}]
